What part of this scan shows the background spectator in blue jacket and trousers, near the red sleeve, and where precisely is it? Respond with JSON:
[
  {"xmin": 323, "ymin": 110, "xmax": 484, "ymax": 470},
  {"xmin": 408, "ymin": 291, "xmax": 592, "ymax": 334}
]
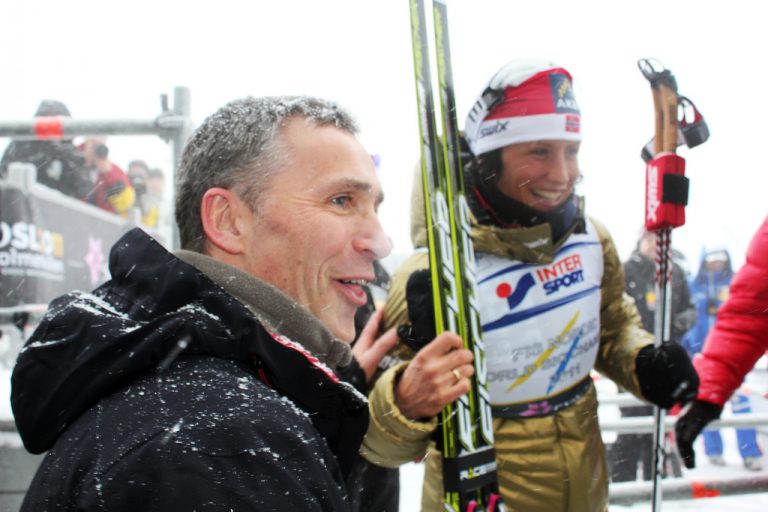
[{"xmin": 685, "ymin": 247, "xmax": 762, "ymax": 471}]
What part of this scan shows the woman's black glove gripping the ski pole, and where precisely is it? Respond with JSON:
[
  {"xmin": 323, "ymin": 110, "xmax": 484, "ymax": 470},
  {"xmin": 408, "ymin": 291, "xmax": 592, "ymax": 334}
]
[{"xmin": 635, "ymin": 343, "xmax": 699, "ymax": 409}]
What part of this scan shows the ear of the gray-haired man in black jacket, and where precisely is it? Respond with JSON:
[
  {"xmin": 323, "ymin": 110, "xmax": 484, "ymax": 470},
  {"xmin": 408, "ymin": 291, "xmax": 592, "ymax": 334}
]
[{"xmin": 200, "ymin": 187, "xmax": 244, "ymax": 254}]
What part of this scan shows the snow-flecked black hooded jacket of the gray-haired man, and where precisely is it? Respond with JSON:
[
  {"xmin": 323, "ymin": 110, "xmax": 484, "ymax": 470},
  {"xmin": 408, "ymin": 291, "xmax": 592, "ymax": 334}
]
[{"xmin": 12, "ymin": 230, "xmax": 368, "ymax": 511}]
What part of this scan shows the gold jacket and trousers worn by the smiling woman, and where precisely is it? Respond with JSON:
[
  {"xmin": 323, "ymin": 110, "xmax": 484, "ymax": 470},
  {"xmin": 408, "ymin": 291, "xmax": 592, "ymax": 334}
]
[{"xmin": 362, "ymin": 175, "xmax": 653, "ymax": 512}]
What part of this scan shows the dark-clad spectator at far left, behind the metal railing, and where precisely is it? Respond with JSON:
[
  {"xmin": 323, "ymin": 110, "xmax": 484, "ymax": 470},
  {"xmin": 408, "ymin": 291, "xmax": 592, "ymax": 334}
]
[{"xmin": 0, "ymin": 100, "xmax": 91, "ymax": 199}]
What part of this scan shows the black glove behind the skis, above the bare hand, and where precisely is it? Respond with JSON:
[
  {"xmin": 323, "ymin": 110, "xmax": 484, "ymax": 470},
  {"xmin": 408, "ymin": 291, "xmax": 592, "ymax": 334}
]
[{"xmin": 397, "ymin": 269, "xmax": 436, "ymax": 352}]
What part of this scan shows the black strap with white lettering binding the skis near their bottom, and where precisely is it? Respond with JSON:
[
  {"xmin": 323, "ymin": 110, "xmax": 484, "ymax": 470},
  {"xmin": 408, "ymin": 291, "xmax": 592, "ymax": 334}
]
[{"xmin": 443, "ymin": 446, "xmax": 496, "ymax": 493}]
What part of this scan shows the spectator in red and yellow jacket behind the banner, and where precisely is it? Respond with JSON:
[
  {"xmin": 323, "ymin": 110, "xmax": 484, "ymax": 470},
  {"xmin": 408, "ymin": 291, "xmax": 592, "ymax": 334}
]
[{"xmin": 81, "ymin": 138, "xmax": 136, "ymax": 218}]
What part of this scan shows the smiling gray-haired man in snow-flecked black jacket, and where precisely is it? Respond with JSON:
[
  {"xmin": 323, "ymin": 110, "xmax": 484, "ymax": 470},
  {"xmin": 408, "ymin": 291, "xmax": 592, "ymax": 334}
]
[{"xmin": 12, "ymin": 97, "xmax": 402, "ymax": 511}]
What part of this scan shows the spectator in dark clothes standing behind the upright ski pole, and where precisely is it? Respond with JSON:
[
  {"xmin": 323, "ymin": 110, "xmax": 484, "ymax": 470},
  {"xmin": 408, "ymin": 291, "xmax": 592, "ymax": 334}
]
[{"xmin": 610, "ymin": 230, "xmax": 696, "ymax": 482}]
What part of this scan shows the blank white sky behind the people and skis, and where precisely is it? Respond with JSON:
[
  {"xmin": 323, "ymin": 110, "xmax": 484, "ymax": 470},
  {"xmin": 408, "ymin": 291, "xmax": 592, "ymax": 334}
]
[{"xmin": 0, "ymin": 0, "xmax": 768, "ymax": 267}]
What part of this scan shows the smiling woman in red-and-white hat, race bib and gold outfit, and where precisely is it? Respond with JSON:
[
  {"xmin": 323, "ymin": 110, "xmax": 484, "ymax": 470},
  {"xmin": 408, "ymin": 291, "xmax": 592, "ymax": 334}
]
[{"xmin": 363, "ymin": 59, "xmax": 698, "ymax": 512}]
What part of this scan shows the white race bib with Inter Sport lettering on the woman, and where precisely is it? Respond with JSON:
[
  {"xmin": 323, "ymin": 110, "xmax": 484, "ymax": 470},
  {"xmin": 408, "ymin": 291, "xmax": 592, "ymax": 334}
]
[{"xmin": 477, "ymin": 223, "xmax": 603, "ymax": 406}]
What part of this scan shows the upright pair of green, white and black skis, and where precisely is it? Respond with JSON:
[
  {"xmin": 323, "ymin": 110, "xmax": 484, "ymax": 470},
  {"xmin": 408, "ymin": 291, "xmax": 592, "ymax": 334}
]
[{"xmin": 409, "ymin": 0, "xmax": 506, "ymax": 512}]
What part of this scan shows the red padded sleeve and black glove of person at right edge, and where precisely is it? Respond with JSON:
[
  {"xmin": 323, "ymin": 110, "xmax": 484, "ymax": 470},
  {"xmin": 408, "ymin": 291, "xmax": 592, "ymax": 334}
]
[{"xmin": 675, "ymin": 217, "xmax": 768, "ymax": 468}]
